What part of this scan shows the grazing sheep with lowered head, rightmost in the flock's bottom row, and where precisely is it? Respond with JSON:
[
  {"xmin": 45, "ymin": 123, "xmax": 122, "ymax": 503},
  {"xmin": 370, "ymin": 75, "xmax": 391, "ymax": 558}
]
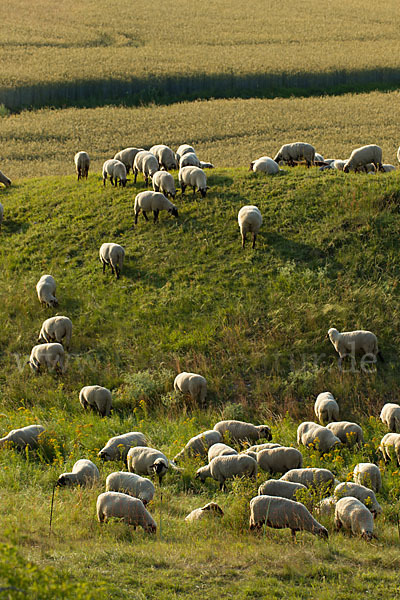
[{"xmin": 335, "ymin": 496, "xmax": 374, "ymax": 540}]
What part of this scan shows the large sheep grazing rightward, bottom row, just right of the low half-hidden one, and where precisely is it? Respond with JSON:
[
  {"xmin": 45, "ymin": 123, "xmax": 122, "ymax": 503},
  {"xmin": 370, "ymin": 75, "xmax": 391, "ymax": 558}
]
[{"xmin": 249, "ymin": 495, "xmax": 329, "ymax": 540}]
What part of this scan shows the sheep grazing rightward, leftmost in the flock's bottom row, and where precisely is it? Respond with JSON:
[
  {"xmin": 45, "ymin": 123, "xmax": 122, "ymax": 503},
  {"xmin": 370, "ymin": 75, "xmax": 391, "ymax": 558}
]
[{"xmin": 96, "ymin": 492, "xmax": 157, "ymax": 533}]
